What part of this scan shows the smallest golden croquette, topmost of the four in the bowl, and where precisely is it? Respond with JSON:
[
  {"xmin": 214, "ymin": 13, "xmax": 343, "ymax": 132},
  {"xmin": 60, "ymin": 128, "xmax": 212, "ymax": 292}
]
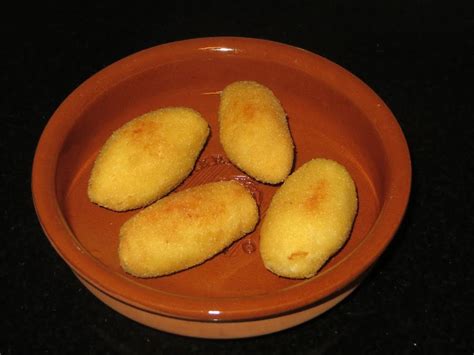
[{"xmin": 219, "ymin": 81, "xmax": 294, "ymax": 184}]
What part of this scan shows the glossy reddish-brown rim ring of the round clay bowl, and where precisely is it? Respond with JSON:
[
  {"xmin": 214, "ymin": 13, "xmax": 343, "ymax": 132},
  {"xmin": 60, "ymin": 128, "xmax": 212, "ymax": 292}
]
[{"xmin": 32, "ymin": 37, "xmax": 411, "ymax": 321}]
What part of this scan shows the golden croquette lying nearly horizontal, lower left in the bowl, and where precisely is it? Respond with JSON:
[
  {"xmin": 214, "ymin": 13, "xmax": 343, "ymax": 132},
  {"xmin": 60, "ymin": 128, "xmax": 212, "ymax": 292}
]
[{"xmin": 119, "ymin": 181, "xmax": 258, "ymax": 277}]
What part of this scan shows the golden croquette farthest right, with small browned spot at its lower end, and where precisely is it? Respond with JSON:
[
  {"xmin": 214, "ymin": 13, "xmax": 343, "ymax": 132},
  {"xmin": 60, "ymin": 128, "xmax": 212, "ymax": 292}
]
[{"xmin": 260, "ymin": 159, "xmax": 357, "ymax": 278}]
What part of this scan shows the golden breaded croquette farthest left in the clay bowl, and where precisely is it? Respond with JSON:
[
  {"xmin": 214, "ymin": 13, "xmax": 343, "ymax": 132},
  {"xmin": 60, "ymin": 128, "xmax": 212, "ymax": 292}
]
[{"xmin": 88, "ymin": 107, "xmax": 209, "ymax": 211}]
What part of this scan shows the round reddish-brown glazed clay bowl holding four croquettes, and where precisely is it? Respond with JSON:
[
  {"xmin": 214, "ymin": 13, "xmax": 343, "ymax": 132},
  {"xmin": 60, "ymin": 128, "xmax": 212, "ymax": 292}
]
[{"xmin": 32, "ymin": 37, "xmax": 411, "ymax": 338}]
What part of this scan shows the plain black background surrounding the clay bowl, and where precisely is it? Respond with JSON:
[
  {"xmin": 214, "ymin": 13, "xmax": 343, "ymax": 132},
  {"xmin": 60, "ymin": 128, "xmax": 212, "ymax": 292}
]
[{"xmin": 0, "ymin": 1, "xmax": 474, "ymax": 355}]
